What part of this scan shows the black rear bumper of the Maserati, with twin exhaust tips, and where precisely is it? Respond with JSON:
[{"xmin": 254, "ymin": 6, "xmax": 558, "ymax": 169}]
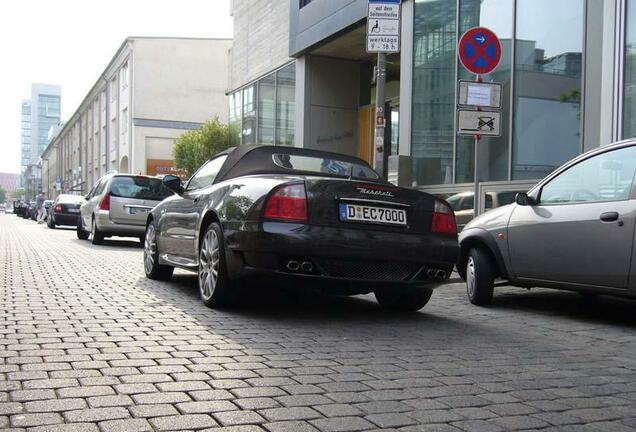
[{"xmin": 226, "ymin": 222, "xmax": 459, "ymax": 293}]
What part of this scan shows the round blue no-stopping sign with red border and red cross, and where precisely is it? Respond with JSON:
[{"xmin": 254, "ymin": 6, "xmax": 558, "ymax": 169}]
[{"xmin": 457, "ymin": 27, "xmax": 501, "ymax": 75}]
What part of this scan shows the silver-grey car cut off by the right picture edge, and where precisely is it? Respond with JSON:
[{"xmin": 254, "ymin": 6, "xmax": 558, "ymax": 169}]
[{"xmin": 457, "ymin": 140, "xmax": 636, "ymax": 305}]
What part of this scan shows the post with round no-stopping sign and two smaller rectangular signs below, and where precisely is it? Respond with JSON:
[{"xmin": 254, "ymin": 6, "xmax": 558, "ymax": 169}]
[{"xmin": 457, "ymin": 27, "xmax": 501, "ymax": 217}]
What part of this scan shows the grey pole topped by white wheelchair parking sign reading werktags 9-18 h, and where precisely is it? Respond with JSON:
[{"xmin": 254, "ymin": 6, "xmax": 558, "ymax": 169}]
[{"xmin": 367, "ymin": 0, "xmax": 401, "ymax": 175}]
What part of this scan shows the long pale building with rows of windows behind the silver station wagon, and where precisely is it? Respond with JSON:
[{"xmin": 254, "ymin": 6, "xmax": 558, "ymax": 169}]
[{"xmin": 42, "ymin": 37, "xmax": 231, "ymax": 197}]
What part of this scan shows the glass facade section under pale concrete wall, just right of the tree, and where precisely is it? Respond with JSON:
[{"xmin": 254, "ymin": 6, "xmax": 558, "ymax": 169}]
[{"xmin": 229, "ymin": 63, "xmax": 296, "ymax": 146}]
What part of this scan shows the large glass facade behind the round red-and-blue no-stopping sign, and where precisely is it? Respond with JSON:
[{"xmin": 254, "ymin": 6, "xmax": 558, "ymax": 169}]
[{"xmin": 411, "ymin": 0, "xmax": 584, "ymax": 186}]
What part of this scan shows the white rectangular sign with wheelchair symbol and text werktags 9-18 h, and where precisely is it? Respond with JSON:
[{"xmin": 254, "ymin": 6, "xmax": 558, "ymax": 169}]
[{"xmin": 367, "ymin": 0, "xmax": 400, "ymax": 53}]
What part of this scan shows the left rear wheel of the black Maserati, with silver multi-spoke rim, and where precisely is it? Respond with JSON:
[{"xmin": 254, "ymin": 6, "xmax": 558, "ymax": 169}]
[{"xmin": 198, "ymin": 222, "xmax": 232, "ymax": 308}]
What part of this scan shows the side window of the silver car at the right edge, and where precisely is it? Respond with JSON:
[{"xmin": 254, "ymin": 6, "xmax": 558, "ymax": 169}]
[{"xmin": 540, "ymin": 147, "xmax": 636, "ymax": 205}]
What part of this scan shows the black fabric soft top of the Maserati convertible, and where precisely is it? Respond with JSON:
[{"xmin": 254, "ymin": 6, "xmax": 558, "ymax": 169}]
[{"xmin": 214, "ymin": 144, "xmax": 383, "ymax": 183}]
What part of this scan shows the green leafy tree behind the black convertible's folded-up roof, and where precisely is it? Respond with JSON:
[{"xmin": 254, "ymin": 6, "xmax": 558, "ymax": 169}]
[{"xmin": 172, "ymin": 117, "xmax": 230, "ymax": 176}]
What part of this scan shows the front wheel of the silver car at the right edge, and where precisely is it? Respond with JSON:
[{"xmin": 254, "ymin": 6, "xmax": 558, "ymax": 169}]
[{"xmin": 466, "ymin": 248, "xmax": 495, "ymax": 306}]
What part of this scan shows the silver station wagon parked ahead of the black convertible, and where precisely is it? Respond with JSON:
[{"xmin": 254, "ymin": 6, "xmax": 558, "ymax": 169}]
[{"xmin": 77, "ymin": 174, "xmax": 173, "ymax": 244}]
